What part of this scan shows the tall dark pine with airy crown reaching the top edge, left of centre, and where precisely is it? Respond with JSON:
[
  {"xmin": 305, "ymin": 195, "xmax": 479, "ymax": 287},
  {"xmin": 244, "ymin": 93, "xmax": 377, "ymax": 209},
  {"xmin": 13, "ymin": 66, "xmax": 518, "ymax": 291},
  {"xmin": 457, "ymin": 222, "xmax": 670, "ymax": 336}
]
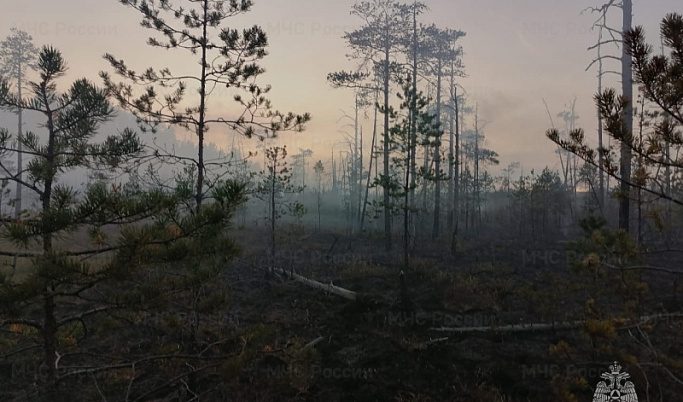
[{"xmin": 100, "ymin": 0, "xmax": 310, "ymax": 211}]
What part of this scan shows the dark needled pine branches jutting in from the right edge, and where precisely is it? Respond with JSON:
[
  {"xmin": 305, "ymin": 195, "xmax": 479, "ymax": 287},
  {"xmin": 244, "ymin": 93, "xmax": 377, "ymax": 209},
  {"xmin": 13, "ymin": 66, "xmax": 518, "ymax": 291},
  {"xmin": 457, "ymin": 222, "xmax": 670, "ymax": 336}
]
[{"xmin": 547, "ymin": 13, "xmax": 683, "ymax": 207}]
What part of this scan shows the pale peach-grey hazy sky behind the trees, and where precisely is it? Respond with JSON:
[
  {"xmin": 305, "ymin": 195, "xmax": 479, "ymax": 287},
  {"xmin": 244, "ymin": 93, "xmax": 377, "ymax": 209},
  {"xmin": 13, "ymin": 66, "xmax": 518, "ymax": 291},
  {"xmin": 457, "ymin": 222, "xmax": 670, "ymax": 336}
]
[{"xmin": 0, "ymin": 0, "xmax": 683, "ymax": 174}]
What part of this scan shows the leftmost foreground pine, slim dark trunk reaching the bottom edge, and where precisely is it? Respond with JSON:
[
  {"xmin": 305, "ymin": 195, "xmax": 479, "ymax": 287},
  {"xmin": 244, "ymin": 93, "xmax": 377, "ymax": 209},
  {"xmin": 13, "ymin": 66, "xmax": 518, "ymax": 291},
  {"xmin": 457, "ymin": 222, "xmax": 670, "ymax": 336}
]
[{"xmin": 0, "ymin": 47, "xmax": 141, "ymax": 400}]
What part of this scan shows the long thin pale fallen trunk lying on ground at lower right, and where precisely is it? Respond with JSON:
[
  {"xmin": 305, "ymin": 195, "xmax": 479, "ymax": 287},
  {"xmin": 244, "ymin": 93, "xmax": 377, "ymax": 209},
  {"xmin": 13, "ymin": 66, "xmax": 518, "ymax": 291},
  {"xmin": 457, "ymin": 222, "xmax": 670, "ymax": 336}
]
[{"xmin": 431, "ymin": 313, "xmax": 683, "ymax": 333}]
